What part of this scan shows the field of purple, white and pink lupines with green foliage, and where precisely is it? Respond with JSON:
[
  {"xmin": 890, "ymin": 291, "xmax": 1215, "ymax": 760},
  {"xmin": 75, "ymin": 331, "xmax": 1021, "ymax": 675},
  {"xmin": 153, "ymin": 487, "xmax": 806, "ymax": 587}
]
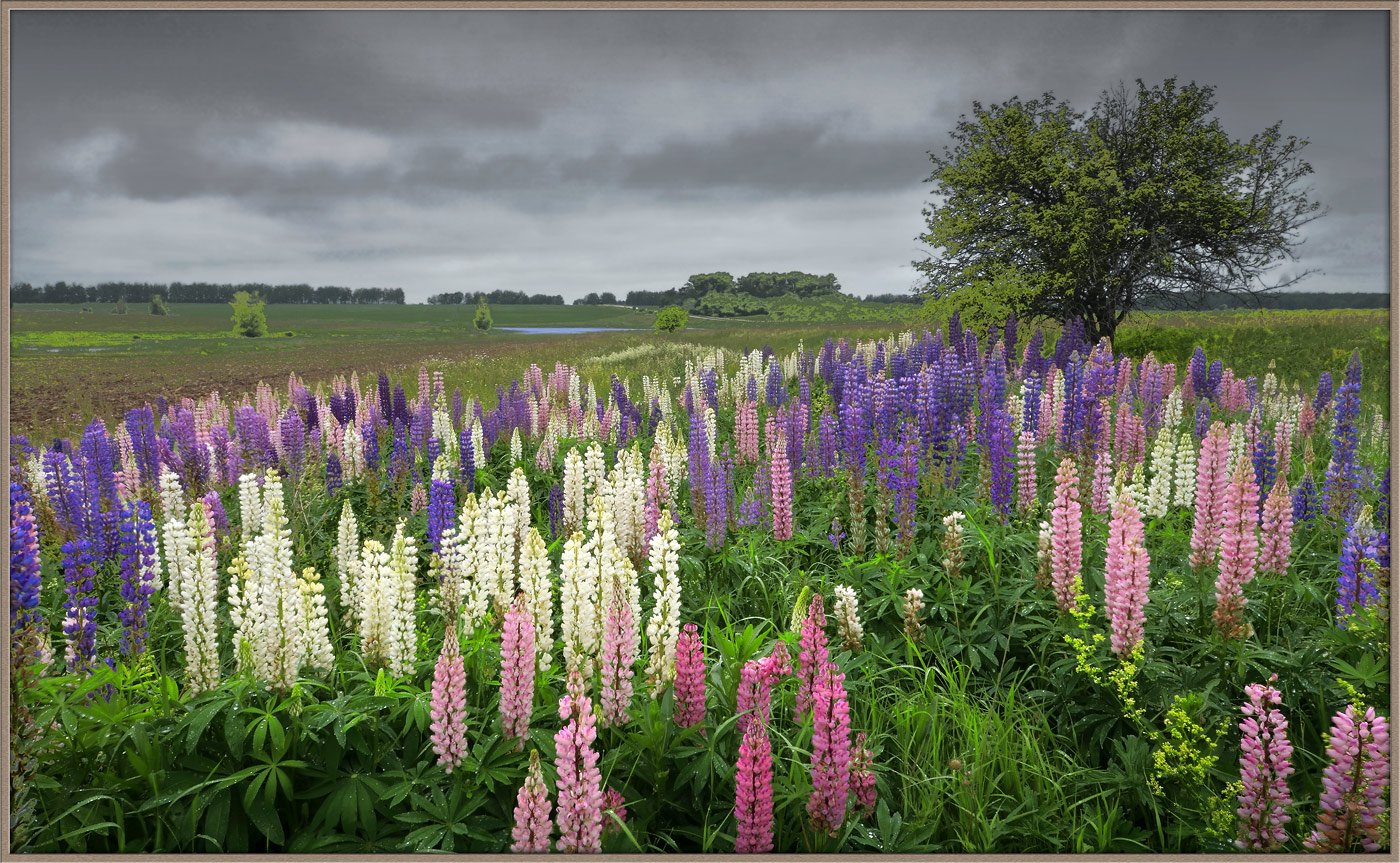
[{"xmin": 10, "ymin": 313, "xmax": 1390, "ymax": 853}]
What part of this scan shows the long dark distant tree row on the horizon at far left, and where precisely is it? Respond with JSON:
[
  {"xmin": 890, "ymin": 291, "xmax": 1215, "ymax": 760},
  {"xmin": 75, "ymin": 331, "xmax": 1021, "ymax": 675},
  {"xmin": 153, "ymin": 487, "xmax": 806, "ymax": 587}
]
[{"xmin": 10, "ymin": 282, "xmax": 403, "ymax": 305}]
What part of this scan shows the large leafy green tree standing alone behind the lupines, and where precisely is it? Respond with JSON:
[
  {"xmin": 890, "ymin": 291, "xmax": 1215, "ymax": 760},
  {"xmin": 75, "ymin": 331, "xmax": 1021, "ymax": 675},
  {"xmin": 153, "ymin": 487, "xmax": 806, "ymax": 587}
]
[{"xmin": 914, "ymin": 78, "xmax": 1323, "ymax": 339}]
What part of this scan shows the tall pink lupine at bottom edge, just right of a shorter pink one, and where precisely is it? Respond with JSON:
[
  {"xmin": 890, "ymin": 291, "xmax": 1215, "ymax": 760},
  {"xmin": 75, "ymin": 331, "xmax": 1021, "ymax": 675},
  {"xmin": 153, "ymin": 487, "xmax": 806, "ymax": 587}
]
[{"xmin": 554, "ymin": 670, "xmax": 603, "ymax": 855}]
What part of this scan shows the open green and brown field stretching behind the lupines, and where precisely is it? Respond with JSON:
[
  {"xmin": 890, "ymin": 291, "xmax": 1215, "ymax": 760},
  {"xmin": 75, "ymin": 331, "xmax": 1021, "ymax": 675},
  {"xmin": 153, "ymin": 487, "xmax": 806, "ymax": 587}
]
[{"xmin": 10, "ymin": 304, "xmax": 1390, "ymax": 436}]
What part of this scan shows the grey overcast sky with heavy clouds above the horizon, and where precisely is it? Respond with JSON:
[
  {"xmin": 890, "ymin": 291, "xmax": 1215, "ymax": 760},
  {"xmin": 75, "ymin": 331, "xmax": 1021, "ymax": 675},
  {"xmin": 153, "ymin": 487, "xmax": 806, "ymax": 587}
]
[{"xmin": 11, "ymin": 10, "xmax": 1389, "ymax": 301}]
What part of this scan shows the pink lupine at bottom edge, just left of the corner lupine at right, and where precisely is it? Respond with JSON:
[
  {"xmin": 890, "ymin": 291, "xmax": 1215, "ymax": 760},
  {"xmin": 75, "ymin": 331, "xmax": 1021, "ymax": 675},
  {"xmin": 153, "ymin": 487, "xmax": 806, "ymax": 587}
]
[{"xmin": 1235, "ymin": 674, "xmax": 1294, "ymax": 850}]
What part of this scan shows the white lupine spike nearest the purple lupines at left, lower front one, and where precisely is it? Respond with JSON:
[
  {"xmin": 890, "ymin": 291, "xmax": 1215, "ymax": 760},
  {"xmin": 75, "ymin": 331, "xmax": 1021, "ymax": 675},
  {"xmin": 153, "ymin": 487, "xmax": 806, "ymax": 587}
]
[{"xmin": 167, "ymin": 502, "xmax": 220, "ymax": 693}]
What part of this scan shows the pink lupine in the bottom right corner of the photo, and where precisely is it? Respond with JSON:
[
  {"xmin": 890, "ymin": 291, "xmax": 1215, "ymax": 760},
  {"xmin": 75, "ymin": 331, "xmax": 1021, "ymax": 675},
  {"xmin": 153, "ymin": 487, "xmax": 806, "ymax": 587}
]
[{"xmin": 1303, "ymin": 705, "xmax": 1390, "ymax": 853}]
